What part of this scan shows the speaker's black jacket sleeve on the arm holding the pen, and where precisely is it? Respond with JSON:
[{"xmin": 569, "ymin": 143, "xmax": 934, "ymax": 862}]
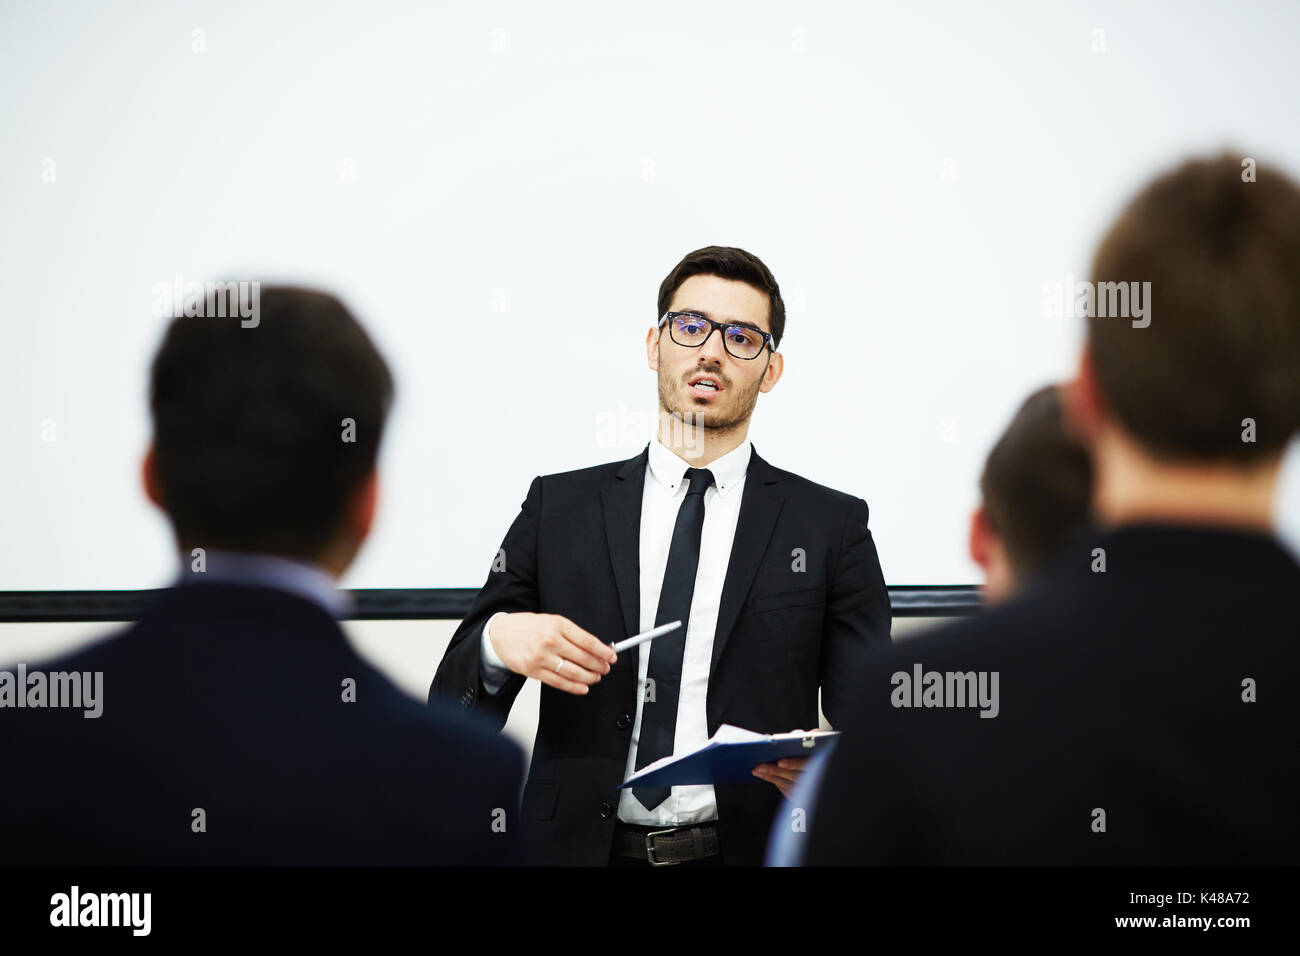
[{"xmin": 429, "ymin": 477, "xmax": 542, "ymax": 730}]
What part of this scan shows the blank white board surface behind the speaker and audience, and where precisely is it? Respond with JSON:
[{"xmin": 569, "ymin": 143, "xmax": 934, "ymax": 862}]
[{"xmin": 0, "ymin": 0, "xmax": 1300, "ymax": 590}]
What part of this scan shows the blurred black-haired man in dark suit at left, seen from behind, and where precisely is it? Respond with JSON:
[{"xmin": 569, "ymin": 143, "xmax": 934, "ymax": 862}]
[{"xmin": 0, "ymin": 289, "xmax": 523, "ymax": 865}]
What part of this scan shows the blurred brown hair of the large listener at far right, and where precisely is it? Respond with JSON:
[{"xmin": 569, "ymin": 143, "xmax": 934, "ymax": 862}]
[{"xmin": 1088, "ymin": 153, "xmax": 1300, "ymax": 463}]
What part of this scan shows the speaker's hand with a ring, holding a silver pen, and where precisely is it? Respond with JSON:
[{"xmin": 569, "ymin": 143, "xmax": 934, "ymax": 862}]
[{"xmin": 488, "ymin": 611, "xmax": 619, "ymax": 695}]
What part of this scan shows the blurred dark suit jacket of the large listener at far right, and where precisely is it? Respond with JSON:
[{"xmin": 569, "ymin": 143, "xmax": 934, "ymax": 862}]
[{"xmin": 805, "ymin": 525, "xmax": 1300, "ymax": 865}]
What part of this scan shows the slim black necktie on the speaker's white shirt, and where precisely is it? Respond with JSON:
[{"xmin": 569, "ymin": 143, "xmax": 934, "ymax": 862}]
[{"xmin": 632, "ymin": 468, "xmax": 714, "ymax": 810}]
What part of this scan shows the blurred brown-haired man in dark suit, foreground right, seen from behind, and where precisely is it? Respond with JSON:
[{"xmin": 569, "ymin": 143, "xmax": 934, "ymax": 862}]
[{"xmin": 793, "ymin": 156, "xmax": 1300, "ymax": 865}]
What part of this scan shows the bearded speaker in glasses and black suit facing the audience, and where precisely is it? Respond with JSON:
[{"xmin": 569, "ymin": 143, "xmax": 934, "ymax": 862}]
[{"xmin": 429, "ymin": 246, "xmax": 891, "ymax": 866}]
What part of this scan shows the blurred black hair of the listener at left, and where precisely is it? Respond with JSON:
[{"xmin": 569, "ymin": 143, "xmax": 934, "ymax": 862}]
[{"xmin": 150, "ymin": 287, "xmax": 393, "ymax": 559}]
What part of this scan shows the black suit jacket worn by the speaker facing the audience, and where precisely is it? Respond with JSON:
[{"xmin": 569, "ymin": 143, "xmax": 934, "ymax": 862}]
[{"xmin": 429, "ymin": 447, "xmax": 891, "ymax": 865}]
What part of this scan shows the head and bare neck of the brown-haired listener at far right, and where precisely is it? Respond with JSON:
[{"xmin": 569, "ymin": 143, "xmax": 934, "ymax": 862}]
[{"xmin": 1063, "ymin": 153, "xmax": 1300, "ymax": 532}]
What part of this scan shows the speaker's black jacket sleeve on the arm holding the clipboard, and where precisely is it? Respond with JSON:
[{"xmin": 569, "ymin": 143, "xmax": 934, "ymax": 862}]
[{"xmin": 819, "ymin": 498, "xmax": 893, "ymax": 727}]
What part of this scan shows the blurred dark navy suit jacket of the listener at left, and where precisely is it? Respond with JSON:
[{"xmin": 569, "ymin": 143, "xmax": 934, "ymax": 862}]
[{"xmin": 0, "ymin": 583, "xmax": 524, "ymax": 866}]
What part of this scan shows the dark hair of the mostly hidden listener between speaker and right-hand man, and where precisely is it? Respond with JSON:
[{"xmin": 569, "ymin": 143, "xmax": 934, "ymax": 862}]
[{"xmin": 979, "ymin": 385, "xmax": 1092, "ymax": 580}]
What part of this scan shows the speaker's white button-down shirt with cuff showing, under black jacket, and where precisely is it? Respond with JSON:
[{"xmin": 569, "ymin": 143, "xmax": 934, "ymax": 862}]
[{"xmin": 480, "ymin": 438, "xmax": 753, "ymax": 827}]
